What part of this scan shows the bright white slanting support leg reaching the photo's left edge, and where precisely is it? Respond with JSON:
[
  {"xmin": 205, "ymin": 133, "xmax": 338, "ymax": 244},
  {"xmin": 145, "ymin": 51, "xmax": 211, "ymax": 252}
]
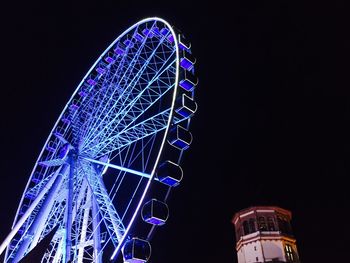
[{"xmin": 0, "ymin": 169, "xmax": 60, "ymax": 255}]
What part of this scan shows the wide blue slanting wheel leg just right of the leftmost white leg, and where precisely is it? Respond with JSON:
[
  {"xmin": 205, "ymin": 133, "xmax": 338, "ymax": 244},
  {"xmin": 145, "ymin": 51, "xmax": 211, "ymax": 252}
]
[{"xmin": 14, "ymin": 166, "xmax": 66, "ymax": 262}]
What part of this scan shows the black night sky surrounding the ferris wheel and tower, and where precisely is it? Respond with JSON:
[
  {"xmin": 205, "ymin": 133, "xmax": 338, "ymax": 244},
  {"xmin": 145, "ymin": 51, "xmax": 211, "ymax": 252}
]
[{"xmin": 0, "ymin": 0, "xmax": 350, "ymax": 263}]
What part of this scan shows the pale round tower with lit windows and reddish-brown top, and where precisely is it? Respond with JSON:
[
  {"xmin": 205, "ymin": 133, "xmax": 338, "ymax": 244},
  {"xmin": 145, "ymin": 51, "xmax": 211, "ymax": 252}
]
[{"xmin": 232, "ymin": 206, "xmax": 300, "ymax": 263}]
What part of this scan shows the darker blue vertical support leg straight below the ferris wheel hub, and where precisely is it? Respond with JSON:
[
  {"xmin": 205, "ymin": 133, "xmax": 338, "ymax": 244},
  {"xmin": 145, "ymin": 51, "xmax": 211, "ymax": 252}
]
[{"xmin": 63, "ymin": 157, "xmax": 74, "ymax": 263}]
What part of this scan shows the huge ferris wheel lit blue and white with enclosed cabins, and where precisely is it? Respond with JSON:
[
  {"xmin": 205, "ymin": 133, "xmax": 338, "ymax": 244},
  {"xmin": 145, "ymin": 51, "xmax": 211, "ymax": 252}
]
[{"xmin": 0, "ymin": 18, "xmax": 198, "ymax": 263}]
